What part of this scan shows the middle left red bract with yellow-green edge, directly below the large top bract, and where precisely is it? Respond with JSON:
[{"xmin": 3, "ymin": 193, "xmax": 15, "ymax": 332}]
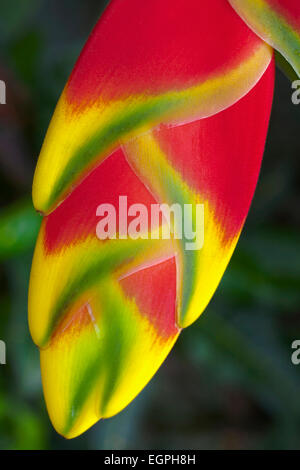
[{"xmin": 29, "ymin": 149, "xmax": 174, "ymax": 348}]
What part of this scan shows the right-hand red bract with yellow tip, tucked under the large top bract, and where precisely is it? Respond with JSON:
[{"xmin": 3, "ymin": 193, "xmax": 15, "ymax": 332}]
[{"xmin": 124, "ymin": 57, "xmax": 274, "ymax": 328}]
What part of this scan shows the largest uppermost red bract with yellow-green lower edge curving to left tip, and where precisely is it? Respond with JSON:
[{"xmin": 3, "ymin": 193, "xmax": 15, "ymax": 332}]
[{"xmin": 33, "ymin": 0, "xmax": 271, "ymax": 213}]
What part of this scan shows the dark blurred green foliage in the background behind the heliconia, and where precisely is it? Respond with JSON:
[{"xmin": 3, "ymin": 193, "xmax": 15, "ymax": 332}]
[{"xmin": 0, "ymin": 0, "xmax": 300, "ymax": 449}]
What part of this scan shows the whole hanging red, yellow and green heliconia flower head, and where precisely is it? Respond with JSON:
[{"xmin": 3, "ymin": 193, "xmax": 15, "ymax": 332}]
[{"xmin": 29, "ymin": 0, "xmax": 298, "ymax": 438}]
